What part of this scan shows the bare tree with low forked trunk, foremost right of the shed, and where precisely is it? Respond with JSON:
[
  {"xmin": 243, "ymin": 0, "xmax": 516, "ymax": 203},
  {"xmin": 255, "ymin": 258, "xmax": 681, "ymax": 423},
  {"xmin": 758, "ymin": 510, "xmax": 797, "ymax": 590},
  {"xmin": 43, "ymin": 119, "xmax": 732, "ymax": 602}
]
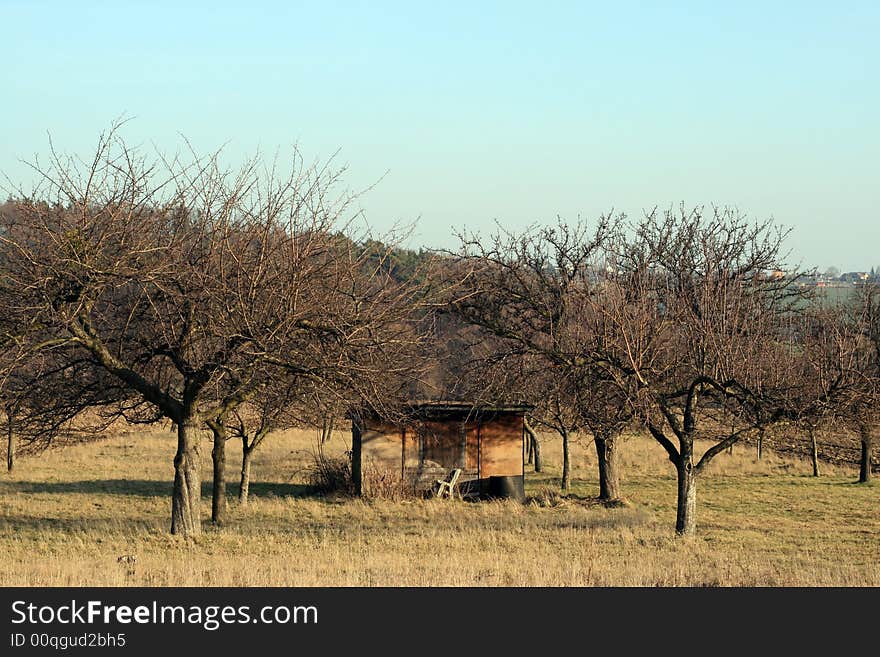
[{"xmin": 596, "ymin": 207, "xmax": 802, "ymax": 535}]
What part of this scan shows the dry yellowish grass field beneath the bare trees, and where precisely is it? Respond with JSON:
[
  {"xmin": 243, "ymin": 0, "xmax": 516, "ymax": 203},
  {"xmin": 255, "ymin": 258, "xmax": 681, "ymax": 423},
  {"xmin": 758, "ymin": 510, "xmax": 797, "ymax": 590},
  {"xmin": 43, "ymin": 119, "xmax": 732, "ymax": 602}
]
[{"xmin": 0, "ymin": 422, "xmax": 880, "ymax": 586}]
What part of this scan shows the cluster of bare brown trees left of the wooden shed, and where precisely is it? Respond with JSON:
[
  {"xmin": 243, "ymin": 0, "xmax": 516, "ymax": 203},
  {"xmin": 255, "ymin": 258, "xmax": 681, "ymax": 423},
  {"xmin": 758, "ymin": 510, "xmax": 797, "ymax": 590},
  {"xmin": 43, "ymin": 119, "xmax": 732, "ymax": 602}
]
[{"xmin": 0, "ymin": 125, "xmax": 436, "ymax": 535}]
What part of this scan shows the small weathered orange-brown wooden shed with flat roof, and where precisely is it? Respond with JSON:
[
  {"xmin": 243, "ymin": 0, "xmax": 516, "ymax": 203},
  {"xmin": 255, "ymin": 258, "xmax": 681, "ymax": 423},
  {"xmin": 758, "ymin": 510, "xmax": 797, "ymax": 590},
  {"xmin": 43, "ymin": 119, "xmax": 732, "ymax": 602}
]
[{"xmin": 352, "ymin": 401, "xmax": 532, "ymax": 497}]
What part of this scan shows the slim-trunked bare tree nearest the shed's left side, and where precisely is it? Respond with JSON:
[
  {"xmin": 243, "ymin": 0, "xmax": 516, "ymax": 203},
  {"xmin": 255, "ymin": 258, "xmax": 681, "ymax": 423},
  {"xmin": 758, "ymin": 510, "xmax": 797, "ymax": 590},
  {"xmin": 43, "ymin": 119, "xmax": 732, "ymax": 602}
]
[{"xmin": 230, "ymin": 236, "xmax": 434, "ymax": 504}]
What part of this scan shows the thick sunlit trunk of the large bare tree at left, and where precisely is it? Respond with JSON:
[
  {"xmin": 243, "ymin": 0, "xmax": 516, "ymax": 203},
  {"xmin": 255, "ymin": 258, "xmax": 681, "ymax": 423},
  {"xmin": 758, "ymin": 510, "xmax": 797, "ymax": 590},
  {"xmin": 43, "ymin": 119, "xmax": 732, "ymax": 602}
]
[{"xmin": 171, "ymin": 418, "xmax": 202, "ymax": 537}]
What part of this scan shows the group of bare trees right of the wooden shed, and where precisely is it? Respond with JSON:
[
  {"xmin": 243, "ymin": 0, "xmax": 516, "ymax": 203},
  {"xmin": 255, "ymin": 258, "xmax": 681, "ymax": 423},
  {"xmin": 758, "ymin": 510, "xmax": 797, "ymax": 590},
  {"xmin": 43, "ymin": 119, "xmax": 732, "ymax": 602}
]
[{"xmin": 454, "ymin": 207, "xmax": 880, "ymax": 534}]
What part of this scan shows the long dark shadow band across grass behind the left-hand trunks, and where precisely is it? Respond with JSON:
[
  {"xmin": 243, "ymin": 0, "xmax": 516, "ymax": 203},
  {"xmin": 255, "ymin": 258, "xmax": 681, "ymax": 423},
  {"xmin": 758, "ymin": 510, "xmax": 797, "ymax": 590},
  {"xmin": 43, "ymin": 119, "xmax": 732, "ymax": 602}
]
[{"xmin": 0, "ymin": 479, "xmax": 317, "ymax": 498}]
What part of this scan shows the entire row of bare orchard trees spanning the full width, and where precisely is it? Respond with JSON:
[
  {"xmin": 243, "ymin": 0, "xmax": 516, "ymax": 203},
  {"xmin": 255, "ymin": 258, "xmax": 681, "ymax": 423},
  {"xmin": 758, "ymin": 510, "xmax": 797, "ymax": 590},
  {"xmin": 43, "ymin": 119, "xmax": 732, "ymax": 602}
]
[{"xmin": 0, "ymin": 129, "xmax": 880, "ymax": 536}]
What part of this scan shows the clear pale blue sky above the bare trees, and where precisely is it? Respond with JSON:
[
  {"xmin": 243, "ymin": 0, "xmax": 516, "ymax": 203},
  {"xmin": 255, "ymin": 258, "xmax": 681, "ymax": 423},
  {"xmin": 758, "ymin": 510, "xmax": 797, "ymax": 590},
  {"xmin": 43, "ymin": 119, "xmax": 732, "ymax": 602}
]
[{"xmin": 0, "ymin": 0, "xmax": 880, "ymax": 270}]
